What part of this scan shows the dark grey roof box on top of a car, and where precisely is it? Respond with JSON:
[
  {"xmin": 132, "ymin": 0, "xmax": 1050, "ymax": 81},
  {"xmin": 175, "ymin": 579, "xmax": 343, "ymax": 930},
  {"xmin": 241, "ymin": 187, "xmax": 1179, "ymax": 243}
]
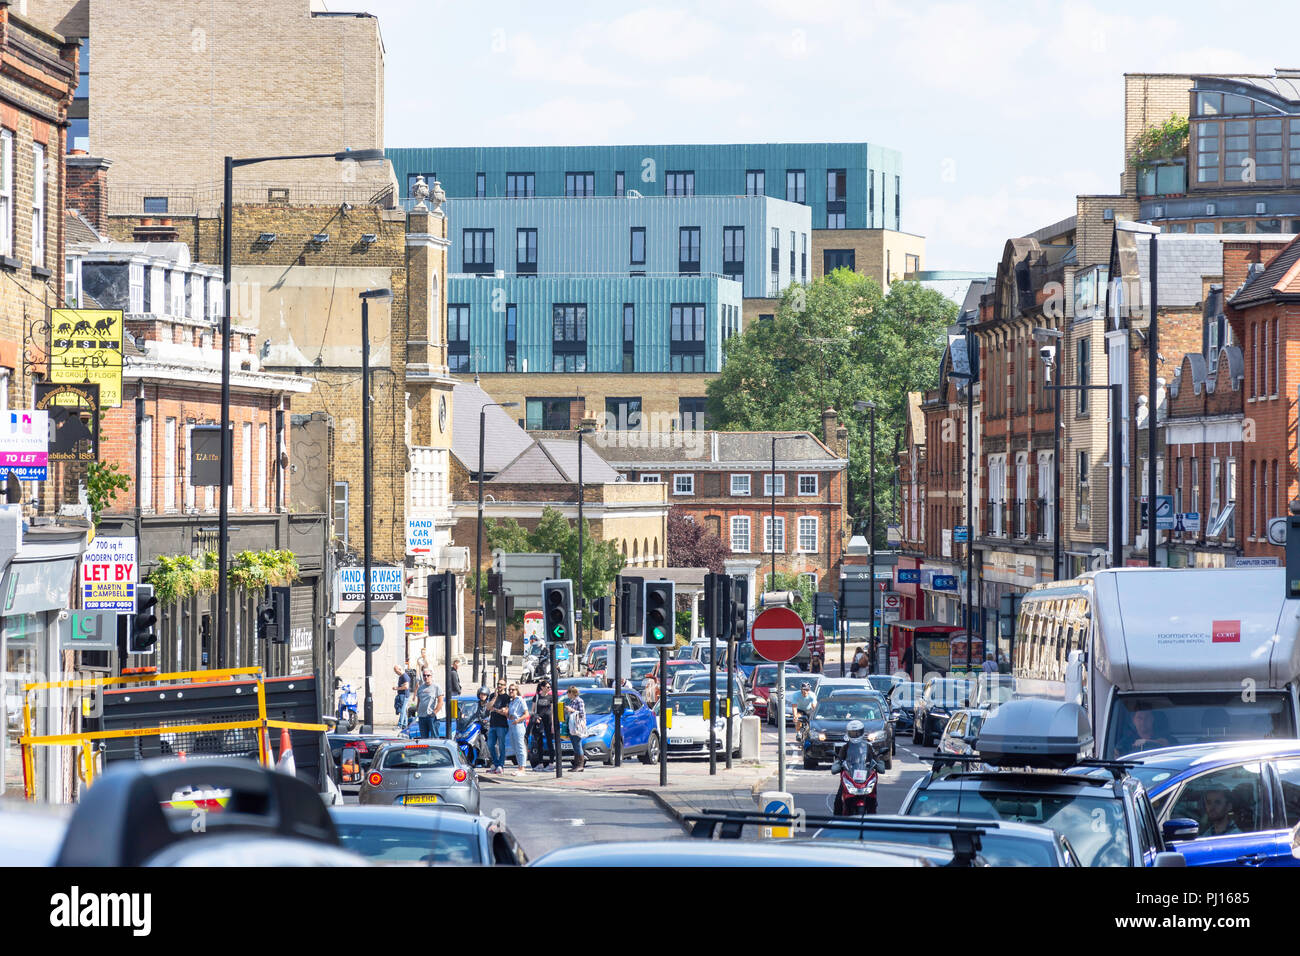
[{"xmin": 975, "ymin": 700, "xmax": 1092, "ymax": 769}]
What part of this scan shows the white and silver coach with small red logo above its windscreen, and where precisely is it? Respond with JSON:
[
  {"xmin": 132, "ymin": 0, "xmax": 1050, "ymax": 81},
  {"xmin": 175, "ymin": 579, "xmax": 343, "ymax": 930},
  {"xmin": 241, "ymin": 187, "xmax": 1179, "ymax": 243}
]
[{"xmin": 1011, "ymin": 568, "xmax": 1300, "ymax": 760}]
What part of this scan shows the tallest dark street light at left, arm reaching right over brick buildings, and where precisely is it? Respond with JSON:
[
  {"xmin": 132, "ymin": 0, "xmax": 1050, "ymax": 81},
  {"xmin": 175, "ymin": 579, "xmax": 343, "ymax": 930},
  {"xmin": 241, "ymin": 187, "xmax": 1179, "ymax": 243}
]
[{"xmin": 217, "ymin": 150, "xmax": 385, "ymax": 665}]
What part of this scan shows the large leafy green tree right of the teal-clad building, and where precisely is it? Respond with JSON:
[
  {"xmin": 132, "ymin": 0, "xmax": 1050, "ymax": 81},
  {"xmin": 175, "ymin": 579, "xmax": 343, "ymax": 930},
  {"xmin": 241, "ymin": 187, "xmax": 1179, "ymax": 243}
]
[{"xmin": 709, "ymin": 269, "xmax": 957, "ymax": 548}]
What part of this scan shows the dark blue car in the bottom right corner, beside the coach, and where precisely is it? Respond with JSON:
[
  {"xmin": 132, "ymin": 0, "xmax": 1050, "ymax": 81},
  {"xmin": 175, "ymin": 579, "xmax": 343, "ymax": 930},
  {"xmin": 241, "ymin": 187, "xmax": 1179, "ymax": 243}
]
[{"xmin": 1122, "ymin": 740, "xmax": 1300, "ymax": 866}]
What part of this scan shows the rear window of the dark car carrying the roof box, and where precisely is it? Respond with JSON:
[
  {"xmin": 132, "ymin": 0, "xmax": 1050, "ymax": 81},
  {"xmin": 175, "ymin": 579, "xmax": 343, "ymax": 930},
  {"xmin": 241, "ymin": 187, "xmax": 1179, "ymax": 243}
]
[{"xmin": 907, "ymin": 790, "xmax": 1130, "ymax": 866}]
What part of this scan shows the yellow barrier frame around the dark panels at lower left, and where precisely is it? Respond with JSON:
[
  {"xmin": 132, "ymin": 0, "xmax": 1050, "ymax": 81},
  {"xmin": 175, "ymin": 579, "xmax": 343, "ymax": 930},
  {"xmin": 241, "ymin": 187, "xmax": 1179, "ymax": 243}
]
[{"xmin": 18, "ymin": 667, "xmax": 326, "ymax": 800}]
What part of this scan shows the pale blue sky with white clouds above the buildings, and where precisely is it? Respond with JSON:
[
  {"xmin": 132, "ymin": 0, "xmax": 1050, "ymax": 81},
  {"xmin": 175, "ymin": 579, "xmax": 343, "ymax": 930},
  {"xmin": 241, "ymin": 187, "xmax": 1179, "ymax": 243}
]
[{"xmin": 338, "ymin": 0, "xmax": 1300, "ymax": 271}]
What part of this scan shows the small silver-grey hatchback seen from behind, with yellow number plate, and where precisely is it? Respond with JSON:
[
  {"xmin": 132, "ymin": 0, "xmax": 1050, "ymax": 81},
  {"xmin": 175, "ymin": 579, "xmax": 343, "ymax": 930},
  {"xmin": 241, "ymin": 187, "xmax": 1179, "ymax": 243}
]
[{"xmin": 358, "ymin": 740, "xmax": 478, "ymax": 813}]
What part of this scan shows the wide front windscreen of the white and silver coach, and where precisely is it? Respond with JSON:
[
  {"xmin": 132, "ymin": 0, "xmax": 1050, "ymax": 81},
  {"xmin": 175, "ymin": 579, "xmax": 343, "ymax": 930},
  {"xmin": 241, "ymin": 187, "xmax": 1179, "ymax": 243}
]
[{"xmin": 1106, "ymin": 691, "xmax": 1296, "ymax": 758}]
